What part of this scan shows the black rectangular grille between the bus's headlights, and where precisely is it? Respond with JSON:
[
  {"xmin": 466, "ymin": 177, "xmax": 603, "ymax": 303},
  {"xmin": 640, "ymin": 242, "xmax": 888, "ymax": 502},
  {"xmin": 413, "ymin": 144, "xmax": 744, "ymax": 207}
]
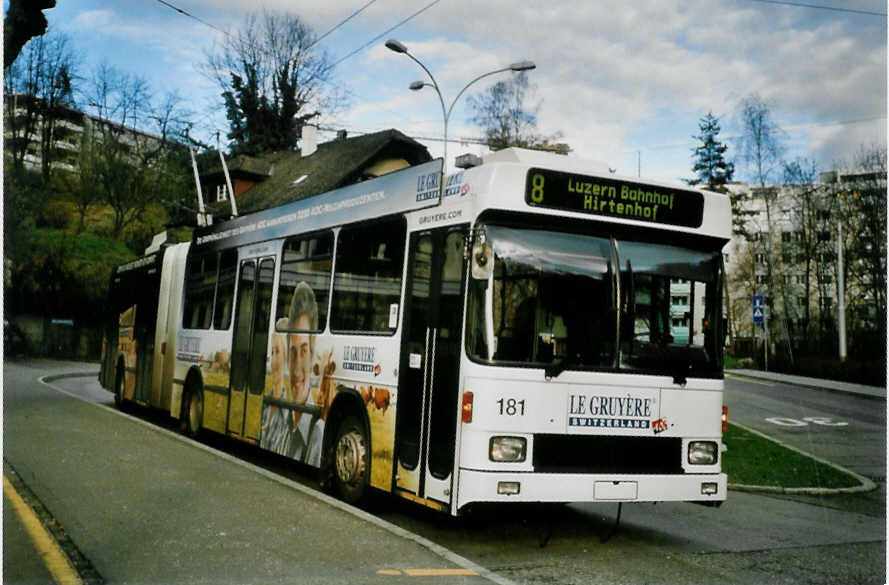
[{"xmin": 533, "ymin": 435, "xmax": 683, "ymax": 475}]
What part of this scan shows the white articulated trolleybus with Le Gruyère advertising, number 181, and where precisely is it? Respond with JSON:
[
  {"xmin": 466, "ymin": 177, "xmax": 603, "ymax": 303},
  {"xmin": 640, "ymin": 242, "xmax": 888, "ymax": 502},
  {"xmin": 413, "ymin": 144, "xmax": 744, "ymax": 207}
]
[{"xmin": 100, "ymin": 149, "xmax": 731, "ymax": 515}]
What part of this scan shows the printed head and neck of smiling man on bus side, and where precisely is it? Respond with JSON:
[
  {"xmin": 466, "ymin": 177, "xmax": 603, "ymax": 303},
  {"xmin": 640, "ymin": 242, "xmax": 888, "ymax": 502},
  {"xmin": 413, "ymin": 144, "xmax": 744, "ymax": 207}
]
[{"xmin": 287, "ymin": 282, "xmax": 318, "ymax": 408}]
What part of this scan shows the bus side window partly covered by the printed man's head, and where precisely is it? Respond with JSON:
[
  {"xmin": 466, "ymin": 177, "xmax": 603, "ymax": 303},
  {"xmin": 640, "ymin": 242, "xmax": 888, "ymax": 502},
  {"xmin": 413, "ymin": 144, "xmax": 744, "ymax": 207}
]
[{"xmin": 275, "ymin": 232, "xmax": 333, "ymax": 332}]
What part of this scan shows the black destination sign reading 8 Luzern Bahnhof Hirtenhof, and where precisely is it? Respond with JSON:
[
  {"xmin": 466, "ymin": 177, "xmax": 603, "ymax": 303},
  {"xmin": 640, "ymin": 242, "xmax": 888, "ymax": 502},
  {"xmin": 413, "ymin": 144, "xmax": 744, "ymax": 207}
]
[{"xmin": 525, "ymin": 169, "xmax": 704, "ymax": 228}]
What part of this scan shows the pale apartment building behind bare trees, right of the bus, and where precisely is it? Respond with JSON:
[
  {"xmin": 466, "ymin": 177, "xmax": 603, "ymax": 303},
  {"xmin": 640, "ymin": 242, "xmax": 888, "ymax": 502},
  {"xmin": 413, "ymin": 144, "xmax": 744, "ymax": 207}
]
[{"xmin": 724, "ymin": 164, "xmax": 886, "ymax": 344}]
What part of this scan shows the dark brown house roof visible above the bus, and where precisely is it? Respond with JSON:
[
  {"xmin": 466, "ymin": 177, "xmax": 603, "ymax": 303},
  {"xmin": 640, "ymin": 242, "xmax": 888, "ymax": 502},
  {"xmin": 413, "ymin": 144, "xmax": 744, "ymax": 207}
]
[{"xmin": 212, "ymin": 129, "xmax": 432, "ymax": 213}]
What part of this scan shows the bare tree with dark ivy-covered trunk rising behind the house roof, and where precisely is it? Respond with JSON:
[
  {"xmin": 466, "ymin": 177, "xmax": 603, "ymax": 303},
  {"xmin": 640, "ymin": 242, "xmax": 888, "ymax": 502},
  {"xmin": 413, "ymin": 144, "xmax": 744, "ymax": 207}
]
[{"xmin": 205, "ymin": 11, "xmax": 340, "ymax": 154}]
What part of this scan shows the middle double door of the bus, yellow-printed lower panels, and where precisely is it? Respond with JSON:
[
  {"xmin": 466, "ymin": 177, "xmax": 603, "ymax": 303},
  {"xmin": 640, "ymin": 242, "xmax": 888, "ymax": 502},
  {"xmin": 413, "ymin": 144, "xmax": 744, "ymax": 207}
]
[{"xmin": 227, "ymin": 258, "xmax": 275, "ymax": 440}]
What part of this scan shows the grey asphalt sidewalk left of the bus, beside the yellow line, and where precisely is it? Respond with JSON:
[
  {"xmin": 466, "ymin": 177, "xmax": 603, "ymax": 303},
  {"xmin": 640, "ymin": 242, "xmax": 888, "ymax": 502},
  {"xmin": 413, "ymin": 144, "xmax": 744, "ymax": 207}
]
[{"xmin": 3, "ymin": 362, "xmax": 510, "ymax": 585}]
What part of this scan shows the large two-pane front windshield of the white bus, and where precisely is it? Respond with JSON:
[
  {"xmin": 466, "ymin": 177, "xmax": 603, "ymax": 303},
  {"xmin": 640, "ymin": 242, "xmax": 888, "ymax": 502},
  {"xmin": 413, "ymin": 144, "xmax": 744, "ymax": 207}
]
[{"xmin": 466, "ymin": 224, "xmax": 722, "ymax": 375}]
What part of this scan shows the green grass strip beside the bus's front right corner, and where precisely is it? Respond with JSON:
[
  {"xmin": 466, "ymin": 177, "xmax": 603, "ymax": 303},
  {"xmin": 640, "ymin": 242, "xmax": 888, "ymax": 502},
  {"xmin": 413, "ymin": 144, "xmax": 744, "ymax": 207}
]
[{"xmin": 722, "ymin": 424, "xmax": 861, "ymax": 489}]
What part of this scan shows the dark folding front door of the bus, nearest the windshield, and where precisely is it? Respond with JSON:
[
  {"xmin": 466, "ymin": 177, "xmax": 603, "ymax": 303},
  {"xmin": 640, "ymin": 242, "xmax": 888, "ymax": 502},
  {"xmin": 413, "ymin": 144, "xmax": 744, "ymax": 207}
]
[{"xmin": 395, "ymin": 226, "xmax": 467, "ymax": 505}]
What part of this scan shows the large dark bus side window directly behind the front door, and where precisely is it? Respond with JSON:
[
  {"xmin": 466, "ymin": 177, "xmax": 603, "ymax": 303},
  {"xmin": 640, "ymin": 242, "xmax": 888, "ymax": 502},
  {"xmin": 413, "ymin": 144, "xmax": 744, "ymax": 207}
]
[{"xmin": 330, "ymin": 217, "xmax": 407, "ymax": 333}]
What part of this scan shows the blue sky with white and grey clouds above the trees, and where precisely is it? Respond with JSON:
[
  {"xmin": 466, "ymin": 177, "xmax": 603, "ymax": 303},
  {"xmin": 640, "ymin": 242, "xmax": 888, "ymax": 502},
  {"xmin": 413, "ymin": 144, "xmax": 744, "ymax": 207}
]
[{"xmin": 27, "ymin": 0, "xmax": 887, "ymax": 181}]
